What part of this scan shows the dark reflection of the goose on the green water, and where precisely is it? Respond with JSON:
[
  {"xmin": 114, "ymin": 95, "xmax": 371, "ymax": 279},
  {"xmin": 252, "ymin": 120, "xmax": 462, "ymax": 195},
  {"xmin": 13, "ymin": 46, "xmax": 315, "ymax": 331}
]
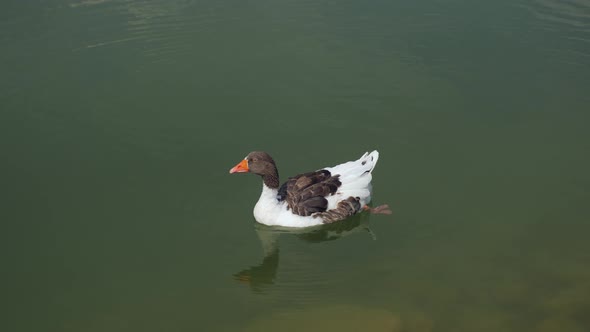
[{"xmin": 234, "ymin": 213, "xmax": 376, "ymax": 293}]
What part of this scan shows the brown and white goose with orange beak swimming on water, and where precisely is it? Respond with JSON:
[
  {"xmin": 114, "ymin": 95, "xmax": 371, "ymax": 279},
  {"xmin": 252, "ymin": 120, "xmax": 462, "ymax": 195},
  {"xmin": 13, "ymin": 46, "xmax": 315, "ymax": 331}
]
[{"xmin": 229, "ymin": 150, "xmax": 391, "ymax": 228}]
